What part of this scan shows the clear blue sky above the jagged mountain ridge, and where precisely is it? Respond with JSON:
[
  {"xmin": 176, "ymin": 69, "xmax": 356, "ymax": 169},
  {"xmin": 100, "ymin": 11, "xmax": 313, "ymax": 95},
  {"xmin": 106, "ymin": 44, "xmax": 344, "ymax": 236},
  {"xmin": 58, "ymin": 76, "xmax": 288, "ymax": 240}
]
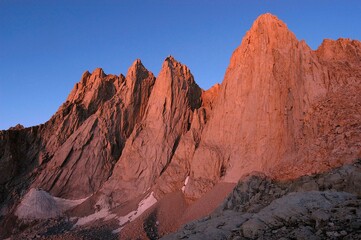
[{"xmin": 0, "ymin": 0, "xmax": 361, "ymax": 129}]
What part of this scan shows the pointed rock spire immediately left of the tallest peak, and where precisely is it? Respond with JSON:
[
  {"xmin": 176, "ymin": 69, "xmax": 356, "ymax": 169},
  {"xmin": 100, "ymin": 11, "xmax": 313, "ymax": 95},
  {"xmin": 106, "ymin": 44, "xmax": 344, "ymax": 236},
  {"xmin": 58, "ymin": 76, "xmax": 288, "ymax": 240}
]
[{"xmin": 105, "ymin": 57, "xmax": 201, "ymax": 204}]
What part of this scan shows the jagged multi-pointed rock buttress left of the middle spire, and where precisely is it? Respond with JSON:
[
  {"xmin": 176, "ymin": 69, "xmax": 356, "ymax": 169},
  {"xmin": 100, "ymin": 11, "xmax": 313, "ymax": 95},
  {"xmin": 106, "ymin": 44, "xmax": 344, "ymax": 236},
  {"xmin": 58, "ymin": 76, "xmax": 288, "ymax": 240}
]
[{"xmin": 33, "ymin": 60, "xmax": 155, "ymax": 199}]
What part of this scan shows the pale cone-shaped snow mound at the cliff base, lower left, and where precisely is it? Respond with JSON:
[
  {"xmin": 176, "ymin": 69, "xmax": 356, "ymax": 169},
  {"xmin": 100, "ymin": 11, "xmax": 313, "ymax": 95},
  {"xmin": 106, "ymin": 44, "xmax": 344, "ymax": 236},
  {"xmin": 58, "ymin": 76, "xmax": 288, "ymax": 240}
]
[{"xmin": 15, "ymin": 188, "xmax": 87, "ymax": 219}]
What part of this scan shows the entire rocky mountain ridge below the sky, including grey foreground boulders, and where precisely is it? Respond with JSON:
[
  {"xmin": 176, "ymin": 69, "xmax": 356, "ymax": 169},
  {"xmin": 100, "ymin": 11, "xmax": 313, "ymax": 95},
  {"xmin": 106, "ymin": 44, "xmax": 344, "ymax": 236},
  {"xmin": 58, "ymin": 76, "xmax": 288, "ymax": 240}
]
[{"xmin": 0, "ymin": 14, "xmax": 361, "ymax": 239}]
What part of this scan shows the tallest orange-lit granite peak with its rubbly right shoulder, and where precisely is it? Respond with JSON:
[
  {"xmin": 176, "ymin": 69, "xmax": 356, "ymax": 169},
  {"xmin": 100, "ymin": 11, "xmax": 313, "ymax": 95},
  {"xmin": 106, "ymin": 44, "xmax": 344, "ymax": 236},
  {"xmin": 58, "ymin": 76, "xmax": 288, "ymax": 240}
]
[{"xmin": 186, "ymin": 14, "xmax": 361, "ymax": 198}]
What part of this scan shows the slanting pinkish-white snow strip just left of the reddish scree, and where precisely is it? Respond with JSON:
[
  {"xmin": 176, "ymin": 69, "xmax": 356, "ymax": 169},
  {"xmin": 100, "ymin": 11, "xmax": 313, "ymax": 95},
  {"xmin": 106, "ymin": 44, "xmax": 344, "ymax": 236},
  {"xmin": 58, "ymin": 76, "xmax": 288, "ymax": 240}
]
[{"xmin": 113, "ymin": 192, "xmax": 157, "ymax": 233}]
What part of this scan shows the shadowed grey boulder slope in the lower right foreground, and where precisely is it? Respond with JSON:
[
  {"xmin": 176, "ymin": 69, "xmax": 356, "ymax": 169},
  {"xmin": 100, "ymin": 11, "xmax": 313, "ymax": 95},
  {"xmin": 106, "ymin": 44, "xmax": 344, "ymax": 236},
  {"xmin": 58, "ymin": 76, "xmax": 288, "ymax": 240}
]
[{"xmin": 162, "ymin": 159, "xmax": 361, "ymax": 240}]
